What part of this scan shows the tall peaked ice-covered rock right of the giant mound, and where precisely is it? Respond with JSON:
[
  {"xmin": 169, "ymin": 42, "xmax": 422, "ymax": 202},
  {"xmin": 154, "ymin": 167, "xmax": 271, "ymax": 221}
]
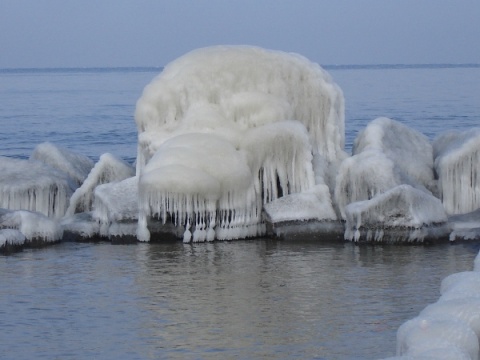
[{"xmin": 335, "ymin": 118, "xmax": 437, "ymax": 219}]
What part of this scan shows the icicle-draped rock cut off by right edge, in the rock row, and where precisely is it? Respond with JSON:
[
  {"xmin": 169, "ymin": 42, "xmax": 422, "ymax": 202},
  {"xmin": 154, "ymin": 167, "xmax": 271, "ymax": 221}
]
[{"xmin": 433, "ymin": 128, "xmax": 480, "ymax": 214}]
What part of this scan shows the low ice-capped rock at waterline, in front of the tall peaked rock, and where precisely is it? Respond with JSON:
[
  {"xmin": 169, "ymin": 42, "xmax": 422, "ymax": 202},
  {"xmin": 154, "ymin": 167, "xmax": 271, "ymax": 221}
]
[{"xmin": 345, "ymin": 185, "xmax": 447, "ymax": 241}]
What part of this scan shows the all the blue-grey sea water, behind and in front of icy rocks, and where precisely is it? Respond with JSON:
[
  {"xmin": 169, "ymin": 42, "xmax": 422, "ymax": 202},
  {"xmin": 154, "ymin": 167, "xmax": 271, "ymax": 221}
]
[{"xmin": 0, "ymin": 65, "xmax": 480, "ymax": 359}]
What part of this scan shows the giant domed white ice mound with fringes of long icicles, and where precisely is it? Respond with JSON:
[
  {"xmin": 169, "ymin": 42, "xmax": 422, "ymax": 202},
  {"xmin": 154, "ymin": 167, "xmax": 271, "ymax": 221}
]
[{"xmin": 135, "ymin": 46, "xmax": 345, "ymax": 241}]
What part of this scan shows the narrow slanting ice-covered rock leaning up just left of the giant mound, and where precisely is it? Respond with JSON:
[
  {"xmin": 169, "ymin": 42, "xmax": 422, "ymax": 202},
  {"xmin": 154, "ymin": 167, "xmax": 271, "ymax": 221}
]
[{"xmin": 66, "ymin": 153, "xmax": 135, "ymax": 216}]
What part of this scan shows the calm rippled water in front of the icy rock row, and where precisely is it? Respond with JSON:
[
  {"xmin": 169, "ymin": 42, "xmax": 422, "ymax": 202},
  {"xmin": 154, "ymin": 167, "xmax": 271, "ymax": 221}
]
[{"xmin": 0, "ymin": 240, "xmax": 479, "ymax": 359}]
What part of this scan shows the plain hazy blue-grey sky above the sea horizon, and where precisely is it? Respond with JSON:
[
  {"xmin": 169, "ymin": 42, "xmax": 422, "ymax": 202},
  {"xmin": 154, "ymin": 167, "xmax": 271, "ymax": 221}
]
[{"xmin": 0, "ymin": 0, "xmax": 480, "ymax": 68}]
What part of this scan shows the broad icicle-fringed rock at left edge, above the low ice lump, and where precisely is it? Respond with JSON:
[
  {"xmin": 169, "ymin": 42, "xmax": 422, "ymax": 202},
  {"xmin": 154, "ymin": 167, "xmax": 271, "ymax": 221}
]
[{"xmin": 0, "ymin": 156, "xmax": 76, "ymax": 218}]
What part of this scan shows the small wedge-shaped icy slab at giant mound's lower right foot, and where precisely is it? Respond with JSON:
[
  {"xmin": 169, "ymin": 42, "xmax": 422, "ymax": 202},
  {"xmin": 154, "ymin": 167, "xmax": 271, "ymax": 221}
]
[{"xmin": 264, "ymin": 185, "xmax": 337, "ymax": 223}]
